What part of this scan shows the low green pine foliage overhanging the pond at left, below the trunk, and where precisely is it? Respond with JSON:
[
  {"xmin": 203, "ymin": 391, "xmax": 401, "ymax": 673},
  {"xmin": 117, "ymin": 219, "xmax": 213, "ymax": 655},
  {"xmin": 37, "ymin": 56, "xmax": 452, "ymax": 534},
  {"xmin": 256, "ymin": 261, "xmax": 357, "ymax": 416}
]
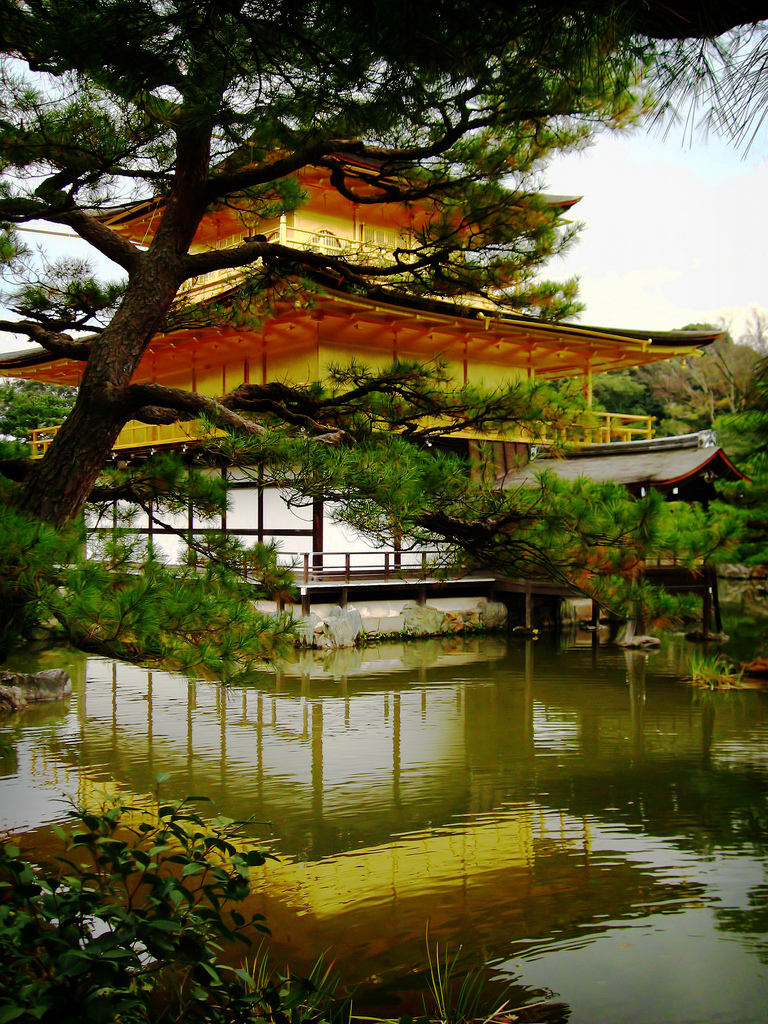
[{"xmin": 0, "ymin": 504, "xmax": 295, "ymax": 681}]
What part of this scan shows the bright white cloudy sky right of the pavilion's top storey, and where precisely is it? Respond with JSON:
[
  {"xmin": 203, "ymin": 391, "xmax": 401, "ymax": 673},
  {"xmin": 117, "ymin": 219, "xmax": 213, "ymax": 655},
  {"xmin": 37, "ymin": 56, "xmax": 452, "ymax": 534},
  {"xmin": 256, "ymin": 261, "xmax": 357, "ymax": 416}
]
[{"xmin": 546, "ymin": 119, "xmax": 768, "ymax": 340}]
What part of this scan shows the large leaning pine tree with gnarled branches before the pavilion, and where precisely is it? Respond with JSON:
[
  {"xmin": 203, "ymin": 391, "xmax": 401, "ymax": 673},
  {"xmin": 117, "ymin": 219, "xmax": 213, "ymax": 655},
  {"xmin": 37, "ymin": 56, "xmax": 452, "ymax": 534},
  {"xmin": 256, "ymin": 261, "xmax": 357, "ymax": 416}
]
[{"xmin": 0, "ymin": 0, "xmax": 753, "ymax": 671}]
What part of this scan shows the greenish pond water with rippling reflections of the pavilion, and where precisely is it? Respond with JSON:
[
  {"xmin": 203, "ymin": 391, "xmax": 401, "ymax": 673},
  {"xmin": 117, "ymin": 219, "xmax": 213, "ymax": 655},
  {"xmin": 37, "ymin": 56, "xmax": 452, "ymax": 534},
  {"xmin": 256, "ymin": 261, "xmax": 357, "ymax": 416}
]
[{"xmin": 0, "ymin": 637, "xmax": 768, "ymax": 1024}]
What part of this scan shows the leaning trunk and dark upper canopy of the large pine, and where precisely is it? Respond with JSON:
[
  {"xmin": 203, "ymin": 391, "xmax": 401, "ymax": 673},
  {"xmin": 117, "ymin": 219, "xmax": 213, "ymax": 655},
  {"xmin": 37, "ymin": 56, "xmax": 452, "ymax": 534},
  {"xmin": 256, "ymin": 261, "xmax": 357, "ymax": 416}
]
[{"xmin": 0, "ymin": 0, "xmax": 696, "ymax": 523}]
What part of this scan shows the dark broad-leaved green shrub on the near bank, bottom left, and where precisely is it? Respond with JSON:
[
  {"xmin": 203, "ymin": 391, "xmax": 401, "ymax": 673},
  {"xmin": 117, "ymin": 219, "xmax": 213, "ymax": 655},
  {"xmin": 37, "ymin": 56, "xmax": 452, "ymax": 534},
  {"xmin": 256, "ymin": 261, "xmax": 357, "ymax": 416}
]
[{"xmin": 0, "ymin": 800, "xmax": 352, "ymax": 1024}]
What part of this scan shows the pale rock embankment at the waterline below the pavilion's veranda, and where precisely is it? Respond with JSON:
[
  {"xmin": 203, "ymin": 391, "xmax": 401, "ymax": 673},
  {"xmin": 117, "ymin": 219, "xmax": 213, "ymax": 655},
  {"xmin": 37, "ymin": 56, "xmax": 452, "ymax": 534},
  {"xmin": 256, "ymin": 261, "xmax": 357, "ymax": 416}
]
[{"xmin": 300, "ymin": 599, "xmax": 507, "ymax": 647}]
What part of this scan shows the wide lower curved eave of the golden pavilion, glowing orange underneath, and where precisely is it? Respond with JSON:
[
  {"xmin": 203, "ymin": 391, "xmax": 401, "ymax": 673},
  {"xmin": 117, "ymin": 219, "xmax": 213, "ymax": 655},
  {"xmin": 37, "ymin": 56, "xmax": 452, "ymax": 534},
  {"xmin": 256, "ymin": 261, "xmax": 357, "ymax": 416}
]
[{"xmin": 0, "ymin": 283, "xmax": 723, "ymax": 384}]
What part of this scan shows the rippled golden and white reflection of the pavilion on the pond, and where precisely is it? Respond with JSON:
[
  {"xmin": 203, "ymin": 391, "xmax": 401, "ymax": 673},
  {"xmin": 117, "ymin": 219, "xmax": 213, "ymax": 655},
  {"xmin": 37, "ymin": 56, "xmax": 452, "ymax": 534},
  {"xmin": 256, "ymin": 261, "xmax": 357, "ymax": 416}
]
[{"xmin": 1, "ymin": 641, "xmax": 720, "ymax": 995}]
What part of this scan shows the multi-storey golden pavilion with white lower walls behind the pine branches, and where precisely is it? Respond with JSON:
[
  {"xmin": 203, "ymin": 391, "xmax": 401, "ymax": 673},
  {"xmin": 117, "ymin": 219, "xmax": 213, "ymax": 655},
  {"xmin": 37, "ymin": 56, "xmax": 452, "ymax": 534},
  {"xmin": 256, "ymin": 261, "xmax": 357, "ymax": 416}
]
[{"xmin": 0, "ymin": 159, "xmax": 718, "ymax": 556}]
